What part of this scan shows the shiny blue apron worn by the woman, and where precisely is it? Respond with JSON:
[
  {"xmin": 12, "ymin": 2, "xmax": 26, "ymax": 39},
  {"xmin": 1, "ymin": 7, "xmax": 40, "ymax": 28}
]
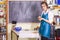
[{"xmin": 39, "ymin": 13, "xmax": 51, "ymax": 38}]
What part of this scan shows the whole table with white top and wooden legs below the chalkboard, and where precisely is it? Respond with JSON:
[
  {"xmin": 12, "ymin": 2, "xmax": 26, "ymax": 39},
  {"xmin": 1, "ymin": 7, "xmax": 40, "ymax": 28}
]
[{"xmin": 11, "ymin": 30, "xmax": 40, "ymax": 40}]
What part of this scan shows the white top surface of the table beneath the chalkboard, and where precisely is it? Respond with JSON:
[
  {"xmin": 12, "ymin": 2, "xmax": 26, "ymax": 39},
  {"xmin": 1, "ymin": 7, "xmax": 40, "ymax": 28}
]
[{"xmin": 12, "ymin": 30, "xmax": 40, "ymax": 38}]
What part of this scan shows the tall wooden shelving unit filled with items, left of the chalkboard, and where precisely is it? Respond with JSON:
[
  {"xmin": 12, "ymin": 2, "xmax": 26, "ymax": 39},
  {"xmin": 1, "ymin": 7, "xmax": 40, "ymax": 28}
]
[{"xmin": 0, "ymin": 0, "xmax": 8, "ymax": 40}]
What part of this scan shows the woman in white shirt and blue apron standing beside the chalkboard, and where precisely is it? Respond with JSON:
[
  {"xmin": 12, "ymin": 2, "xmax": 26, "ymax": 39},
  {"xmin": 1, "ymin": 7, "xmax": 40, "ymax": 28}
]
[{"xmin": 38, "ymin": 2, "xmax": 54, "ymax": 40}]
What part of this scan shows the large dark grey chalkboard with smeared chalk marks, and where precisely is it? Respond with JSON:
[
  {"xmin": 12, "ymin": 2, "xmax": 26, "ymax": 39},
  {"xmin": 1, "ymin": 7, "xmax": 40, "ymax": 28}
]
[{"xmin": 9, "ymin": 1, "xmax": 42, "ymax": 22}]
